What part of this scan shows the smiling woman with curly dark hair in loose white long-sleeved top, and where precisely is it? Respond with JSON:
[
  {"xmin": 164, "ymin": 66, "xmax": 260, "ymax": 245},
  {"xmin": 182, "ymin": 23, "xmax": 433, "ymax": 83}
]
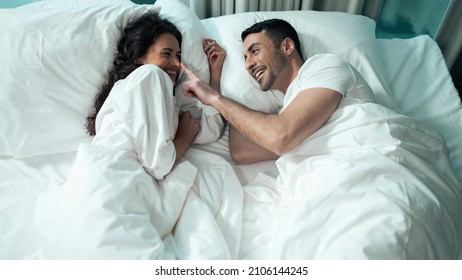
[{"xmin": 86, "ymin": 13, "xmax": 226, "ymax": 179}]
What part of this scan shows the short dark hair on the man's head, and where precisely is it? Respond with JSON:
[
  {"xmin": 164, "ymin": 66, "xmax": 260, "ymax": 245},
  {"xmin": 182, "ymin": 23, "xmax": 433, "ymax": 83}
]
[{"xmin": 241, "ymin": 18, "xmax": 303, "ymax": 59}]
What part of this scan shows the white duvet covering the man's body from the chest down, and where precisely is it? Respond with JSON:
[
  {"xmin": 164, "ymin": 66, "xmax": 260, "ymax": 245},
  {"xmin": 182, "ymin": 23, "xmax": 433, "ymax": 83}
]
[{"xmin": 241, "ymin": 100, "xmax": 462, "ymax": 259}]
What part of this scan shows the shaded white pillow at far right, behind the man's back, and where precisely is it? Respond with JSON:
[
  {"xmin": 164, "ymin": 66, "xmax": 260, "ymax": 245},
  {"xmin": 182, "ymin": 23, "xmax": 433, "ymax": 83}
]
[{"xmin": 379, "ymin": 35, "xmax": 462, "ymax": 186}]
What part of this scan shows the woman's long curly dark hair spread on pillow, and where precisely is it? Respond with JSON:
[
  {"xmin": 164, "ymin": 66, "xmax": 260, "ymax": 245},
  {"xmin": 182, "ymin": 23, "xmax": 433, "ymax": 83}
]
[{"xmin": 85, "ymin": 13, "xmax": 181, "ymax": 136}]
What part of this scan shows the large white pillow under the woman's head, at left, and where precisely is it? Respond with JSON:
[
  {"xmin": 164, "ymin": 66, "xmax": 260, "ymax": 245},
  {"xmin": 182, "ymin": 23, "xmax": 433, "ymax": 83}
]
[{"xmin": 0, "ymin": 0, "xmax": 209, "ymax": 158}]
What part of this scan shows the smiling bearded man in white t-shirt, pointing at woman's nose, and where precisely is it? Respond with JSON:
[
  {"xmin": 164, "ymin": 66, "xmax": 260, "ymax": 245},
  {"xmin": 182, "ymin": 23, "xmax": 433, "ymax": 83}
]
[{"xmin": 183, "ymin": 19, "xmax": 372, "ymax": 163}]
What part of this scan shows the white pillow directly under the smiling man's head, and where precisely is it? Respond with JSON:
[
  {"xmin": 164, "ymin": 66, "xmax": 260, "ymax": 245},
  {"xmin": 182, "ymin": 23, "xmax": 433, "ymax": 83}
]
[{"xmin": 201, "ymin": 11, "xmax": 394, "ymax": 112}]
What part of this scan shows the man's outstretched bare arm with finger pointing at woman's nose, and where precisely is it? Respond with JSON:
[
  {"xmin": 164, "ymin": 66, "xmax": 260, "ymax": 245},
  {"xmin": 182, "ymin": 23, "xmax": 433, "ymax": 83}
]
[{"xmin": 182, "ymin": 65, "xmax": 342, "ymax": 155}]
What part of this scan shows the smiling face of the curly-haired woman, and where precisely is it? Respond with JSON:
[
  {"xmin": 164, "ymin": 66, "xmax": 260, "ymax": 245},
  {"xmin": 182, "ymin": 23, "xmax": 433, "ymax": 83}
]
[{"xmin": 140, "ymin": 33, "xmax": 181, "ymax": 85}]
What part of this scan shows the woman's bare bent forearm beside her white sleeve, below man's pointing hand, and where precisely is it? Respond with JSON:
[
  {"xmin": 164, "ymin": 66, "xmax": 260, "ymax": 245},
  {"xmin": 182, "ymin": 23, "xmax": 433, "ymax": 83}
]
[{"xmin": 173, "ymin": 111, "xmax": 201, "ymax": 161}]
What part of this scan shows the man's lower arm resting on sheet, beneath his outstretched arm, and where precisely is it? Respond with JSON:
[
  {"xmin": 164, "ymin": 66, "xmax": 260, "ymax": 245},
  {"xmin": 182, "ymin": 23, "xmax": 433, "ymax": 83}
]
[{"xmin": 229, "ymin": 124, "xmax": 279, "ymax": 164}]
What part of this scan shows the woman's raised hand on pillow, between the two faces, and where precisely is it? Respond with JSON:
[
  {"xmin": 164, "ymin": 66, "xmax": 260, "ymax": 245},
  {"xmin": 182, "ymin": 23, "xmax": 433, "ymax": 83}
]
[{"xmin": 202, "ymin": 38, "xmax": 226, "ymax": 91}]
